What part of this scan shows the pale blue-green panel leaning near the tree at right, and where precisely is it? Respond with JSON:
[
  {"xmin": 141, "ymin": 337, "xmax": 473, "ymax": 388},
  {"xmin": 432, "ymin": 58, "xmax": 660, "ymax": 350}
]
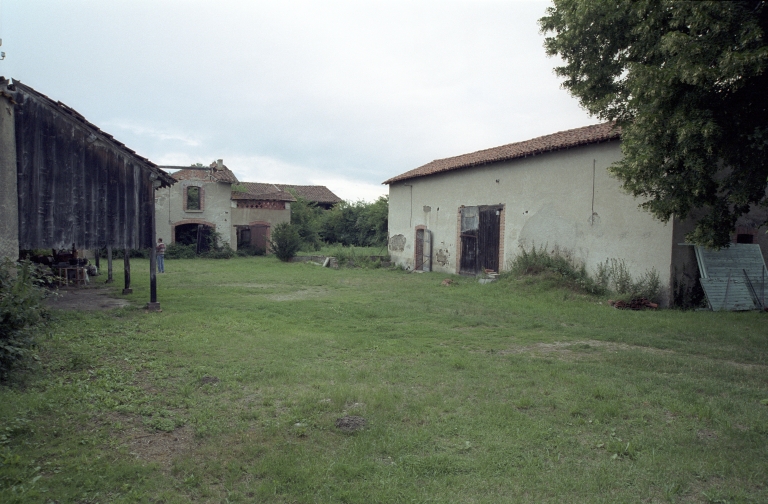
[{"xmin": 695, "ymin": 243, "xmax": 768, "ymax": 311}]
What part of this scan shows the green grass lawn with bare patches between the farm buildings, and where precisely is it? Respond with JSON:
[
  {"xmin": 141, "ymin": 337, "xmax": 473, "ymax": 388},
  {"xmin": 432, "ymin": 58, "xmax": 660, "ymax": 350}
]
[{"xmin": 0, "ymin": 257, "xmax": 768, "ymax": 503}]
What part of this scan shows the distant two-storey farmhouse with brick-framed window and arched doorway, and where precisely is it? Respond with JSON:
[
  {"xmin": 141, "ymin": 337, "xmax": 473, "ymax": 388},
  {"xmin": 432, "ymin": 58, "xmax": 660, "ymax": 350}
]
[{"xmin": 155, "ymin": 163, "xmax": 341, "ymax": 250}]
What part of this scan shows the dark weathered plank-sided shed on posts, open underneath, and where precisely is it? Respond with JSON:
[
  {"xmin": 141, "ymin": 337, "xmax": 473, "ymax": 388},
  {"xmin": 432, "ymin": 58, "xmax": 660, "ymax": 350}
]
[{"xmin": 0, "ymin": 77, "xmax": 175, "ymax": 303}]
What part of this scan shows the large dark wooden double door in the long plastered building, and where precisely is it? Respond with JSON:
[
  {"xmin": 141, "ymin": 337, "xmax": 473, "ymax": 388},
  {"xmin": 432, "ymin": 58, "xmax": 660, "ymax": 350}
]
[{"xmin": 459, "ymin": 205, "xmax": 504, "ymax": 275}]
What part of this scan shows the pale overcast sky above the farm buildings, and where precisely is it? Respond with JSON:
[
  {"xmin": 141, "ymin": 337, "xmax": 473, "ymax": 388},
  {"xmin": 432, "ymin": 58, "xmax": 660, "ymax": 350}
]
[{"xmin": 0, "ymin": 0, "xmax": 597, "ymax": 201}]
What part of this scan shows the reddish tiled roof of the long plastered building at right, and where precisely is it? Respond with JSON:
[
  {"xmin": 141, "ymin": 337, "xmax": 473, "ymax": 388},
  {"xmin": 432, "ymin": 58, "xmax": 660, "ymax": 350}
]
[{"xmin": 383, "ymin": 123, "xmax": 621, "ymax": 184}]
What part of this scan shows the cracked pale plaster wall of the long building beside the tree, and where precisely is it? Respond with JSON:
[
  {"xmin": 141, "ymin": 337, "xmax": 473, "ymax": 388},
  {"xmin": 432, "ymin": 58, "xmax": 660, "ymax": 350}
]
[{"xmin": 389, "ymin": 141, "xmax": 673, "ymax": 304}]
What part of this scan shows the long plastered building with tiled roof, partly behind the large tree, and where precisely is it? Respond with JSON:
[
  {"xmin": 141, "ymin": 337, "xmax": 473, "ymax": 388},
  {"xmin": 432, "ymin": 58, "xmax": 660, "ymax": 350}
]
[{"xmin": 384, "ymin": 123, "xmax": 768, "ymax": 303}]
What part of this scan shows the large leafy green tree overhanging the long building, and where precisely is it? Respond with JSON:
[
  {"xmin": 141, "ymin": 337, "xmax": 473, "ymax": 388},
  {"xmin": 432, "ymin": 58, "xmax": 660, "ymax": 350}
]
[{"xmin": 539, "ymin": 0, "xmax": 768, "ymax": 247}]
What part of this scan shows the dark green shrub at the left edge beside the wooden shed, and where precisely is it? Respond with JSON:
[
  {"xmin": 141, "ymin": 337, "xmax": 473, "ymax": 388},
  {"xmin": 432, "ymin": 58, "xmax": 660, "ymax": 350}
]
[{"xmin": 0, "ymin": 259, "xmax": 49, "ymax": 379}]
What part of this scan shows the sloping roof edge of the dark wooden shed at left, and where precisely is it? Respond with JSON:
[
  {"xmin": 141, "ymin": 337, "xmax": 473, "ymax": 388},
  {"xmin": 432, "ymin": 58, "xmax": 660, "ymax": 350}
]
[{"xmin": 0, "ymin": 76, "xmax": 176, "ymax": 187}]
